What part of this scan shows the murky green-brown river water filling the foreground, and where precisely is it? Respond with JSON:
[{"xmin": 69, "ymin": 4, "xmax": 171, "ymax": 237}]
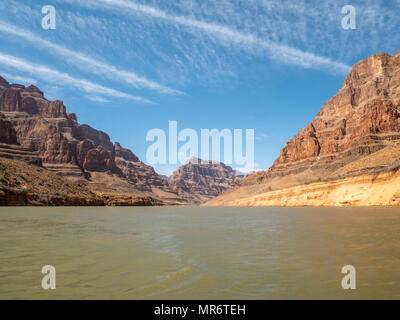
[{"xmin": 0, "ymin": 207, "xmax": 400, "ymax": 299}]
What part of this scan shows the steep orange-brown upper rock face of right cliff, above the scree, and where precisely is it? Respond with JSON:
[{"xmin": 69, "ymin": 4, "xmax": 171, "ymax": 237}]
[{"xmin": 275, "ymin": 53, "xmax": 400, "ymax": 166}]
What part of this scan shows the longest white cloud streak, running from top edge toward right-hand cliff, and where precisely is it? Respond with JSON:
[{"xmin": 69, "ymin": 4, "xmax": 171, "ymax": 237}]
[{"xmin": 69, "ymin": 0, "xmax": 351, "ymax": 74}]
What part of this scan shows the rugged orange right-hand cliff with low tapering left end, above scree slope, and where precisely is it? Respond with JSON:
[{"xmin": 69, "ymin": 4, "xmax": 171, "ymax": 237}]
[{"xmin": 245, "ymin": 52, "xmax": 400, "ymax": 183}]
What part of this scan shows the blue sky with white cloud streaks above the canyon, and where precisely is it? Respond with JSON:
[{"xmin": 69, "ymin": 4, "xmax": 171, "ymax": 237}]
[{"xmin": 0, "ymin": 0, "xmax": 400, "ymax": 175}]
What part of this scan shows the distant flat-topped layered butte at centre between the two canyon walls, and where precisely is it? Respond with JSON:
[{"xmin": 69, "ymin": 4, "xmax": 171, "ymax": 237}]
[{"xmin": 168, "ymin": 159, "xmax": 242, "ymax": 203}]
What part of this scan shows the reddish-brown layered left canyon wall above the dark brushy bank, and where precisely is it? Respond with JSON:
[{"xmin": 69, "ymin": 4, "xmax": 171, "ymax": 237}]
[{"xmin": 0, "ymin": 77, "xmax": 177, "ymax": 200}]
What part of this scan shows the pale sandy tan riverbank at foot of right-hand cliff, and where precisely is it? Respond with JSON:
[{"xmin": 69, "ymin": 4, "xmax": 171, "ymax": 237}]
[{"xmin": 204, "ymin": 169, "xmax": 400, "ymax": 207}]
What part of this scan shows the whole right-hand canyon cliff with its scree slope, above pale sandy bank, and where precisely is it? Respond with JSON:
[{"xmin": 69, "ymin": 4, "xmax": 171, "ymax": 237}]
[{"xmin": 211, "ymin": 51, "xmax": 400, "ymax": 205}]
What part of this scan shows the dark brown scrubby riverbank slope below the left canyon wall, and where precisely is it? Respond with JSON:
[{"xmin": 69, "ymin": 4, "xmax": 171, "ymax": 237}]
[{"xmin": 0, "ymin": 158, "xmax": 167, "ymax": 206}]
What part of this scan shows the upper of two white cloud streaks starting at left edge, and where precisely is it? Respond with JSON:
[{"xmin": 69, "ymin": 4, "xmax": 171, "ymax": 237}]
[{"xmin": 0, "ymin": 21, "xmax": 182, "ymax": 94}]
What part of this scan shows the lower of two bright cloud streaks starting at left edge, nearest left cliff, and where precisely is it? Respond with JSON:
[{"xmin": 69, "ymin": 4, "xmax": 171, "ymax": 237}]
[{"xmin": 0, "ymin": 52, "xmax": 153, "ymax": 104}]
